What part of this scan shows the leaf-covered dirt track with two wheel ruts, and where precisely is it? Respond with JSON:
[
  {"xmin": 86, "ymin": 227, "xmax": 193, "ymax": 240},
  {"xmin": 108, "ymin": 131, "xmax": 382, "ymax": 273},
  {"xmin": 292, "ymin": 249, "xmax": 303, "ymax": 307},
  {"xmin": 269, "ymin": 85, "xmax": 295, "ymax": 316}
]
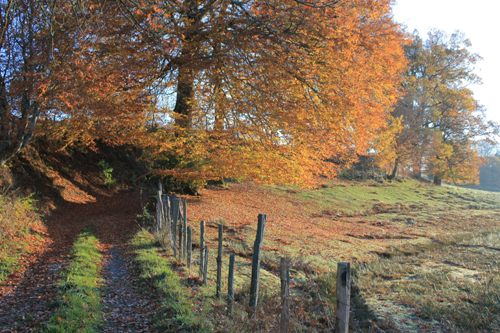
[{"xmin": 0, "ymin": 192, "xmax": 157, "ymax": 332}]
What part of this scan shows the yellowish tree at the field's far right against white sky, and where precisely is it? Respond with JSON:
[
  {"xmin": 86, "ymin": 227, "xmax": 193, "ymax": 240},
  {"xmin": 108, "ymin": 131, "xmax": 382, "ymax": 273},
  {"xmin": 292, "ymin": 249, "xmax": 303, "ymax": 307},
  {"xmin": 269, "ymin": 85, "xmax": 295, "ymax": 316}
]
[{"xmin": 386, "ymin": 31, "xmax": 498, "ymax": 185}]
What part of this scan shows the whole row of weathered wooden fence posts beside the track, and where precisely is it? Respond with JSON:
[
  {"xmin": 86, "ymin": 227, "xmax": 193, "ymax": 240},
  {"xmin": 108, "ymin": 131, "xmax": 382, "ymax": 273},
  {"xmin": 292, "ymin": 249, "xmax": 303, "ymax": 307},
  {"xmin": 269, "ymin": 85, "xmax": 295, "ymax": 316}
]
[{"xmin": 153, "ymin": 183, "xmax": 351, "ymax": 333}]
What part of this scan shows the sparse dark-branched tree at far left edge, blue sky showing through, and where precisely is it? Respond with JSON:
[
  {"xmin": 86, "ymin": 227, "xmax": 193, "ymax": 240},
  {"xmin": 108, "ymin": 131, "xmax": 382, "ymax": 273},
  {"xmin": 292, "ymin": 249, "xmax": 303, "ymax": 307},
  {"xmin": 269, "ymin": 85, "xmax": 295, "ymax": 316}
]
[{"xmin": 0, "ymin": 0, "xmax": 53, "ymax": 165}]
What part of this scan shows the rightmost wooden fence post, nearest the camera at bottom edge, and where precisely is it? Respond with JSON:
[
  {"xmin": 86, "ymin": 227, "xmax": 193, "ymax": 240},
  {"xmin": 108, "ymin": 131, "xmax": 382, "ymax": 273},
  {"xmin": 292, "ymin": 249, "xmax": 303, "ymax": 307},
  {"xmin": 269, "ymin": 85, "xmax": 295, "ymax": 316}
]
[{"xmin": 335, "ymin": 262, "xmax": 351, "ymax": 333}]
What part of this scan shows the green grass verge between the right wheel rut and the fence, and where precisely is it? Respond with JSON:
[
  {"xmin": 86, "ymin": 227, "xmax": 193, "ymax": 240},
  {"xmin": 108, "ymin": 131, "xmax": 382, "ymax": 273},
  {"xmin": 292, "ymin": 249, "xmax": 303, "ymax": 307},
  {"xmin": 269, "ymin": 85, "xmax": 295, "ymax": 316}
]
[{"xmin": 131, "ymin": 230, "xmax": 203, "ymax": 332}]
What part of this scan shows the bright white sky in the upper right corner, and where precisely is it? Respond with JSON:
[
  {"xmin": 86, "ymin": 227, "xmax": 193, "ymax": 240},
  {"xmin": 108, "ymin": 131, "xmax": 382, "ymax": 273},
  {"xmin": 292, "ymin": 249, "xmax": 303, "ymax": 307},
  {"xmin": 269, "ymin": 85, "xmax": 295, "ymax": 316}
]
[{"xmin": 393, "ymin": 0, "xmax": 500, "ymax": 123}]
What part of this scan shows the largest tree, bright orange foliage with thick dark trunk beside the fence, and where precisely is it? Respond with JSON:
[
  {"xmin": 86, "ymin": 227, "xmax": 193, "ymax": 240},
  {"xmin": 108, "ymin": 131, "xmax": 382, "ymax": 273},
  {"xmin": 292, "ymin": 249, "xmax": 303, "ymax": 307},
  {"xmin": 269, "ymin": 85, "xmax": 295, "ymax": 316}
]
[{"xmin": 118, "ymin": 0, "xmax": 404, "ymax": 183}]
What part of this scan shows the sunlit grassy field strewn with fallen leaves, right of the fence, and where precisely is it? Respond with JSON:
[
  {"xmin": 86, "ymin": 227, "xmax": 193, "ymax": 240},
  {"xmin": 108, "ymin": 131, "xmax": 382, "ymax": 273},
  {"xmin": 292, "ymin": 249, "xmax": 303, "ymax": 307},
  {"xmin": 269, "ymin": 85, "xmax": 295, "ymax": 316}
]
[{"xmin": 135, "ymin": 180, "xmax": 500, "ymax": 332}]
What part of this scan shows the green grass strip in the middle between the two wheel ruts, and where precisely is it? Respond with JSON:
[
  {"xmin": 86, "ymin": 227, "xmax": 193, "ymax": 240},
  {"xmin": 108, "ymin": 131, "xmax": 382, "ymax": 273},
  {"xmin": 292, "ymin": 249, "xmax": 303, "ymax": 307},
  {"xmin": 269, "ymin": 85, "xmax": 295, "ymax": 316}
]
[{"xmin": 45, "ymin": 227, "xmax": 102, "ymax": 332}]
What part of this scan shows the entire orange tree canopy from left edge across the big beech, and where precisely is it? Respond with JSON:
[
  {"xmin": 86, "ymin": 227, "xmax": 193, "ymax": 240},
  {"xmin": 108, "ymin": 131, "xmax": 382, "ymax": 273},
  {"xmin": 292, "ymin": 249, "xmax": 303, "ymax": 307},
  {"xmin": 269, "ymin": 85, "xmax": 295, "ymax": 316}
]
[{"xmin": 0, "ymin": 0, "xmax": 405, "ymax": 183}]
